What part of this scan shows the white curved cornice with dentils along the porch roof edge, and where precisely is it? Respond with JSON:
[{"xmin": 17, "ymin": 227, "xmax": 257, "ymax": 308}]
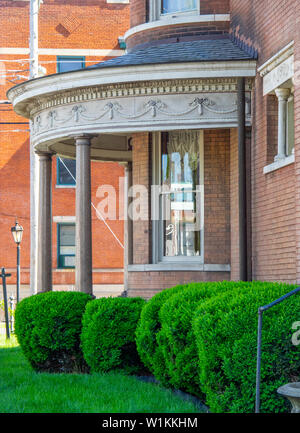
[{"xmin": 7, "ymin": 60, "xmax": 256, "ymax": 117}]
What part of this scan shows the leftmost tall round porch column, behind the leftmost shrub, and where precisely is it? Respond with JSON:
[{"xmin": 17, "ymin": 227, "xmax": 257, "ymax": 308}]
[{"xmin": 36, "ymin": 152, "xmax": 52, "ymax": 292}]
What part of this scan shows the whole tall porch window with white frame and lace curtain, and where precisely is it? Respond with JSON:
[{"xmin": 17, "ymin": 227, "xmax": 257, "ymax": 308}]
[{"xmin": 153, "ymin": 131, "xmax": 204, "ymax": 263}]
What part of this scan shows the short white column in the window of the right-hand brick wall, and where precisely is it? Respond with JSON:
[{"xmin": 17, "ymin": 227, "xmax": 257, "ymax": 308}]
[{"xmin": 275, "ymin": 88, "xmax": 290, "ymax": 161}]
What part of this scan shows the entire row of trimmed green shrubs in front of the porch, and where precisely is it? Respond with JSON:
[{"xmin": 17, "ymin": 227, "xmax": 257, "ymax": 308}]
[{"xmin": 15, "ymin": 281, "xmax": 300, "ymax": 413}]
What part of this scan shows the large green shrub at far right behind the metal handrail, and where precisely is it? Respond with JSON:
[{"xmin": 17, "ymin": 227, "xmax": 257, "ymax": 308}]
[{"xmin": 193, "ymin": 282, "xmax": 300, "ymax": 412}]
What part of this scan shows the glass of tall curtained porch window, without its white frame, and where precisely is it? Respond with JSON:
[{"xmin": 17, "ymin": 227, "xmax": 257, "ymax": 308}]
[{"xmin": 160, "ymin": 131, "xmax": 202, "ymax": 257}]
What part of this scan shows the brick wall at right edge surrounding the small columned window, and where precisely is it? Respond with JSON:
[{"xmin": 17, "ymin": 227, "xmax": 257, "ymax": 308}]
[{"xmin": 230, "ymin": 0, "xmax": 299, "ymax": 282}]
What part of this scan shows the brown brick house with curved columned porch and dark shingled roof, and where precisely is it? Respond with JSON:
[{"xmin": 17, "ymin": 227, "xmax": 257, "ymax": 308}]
[{"xmin": 8, "ymin": 0, "xmax": 300, "ymax": 297}]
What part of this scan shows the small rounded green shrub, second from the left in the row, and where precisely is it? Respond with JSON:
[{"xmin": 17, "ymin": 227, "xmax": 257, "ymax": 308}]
[{"xmin": 81, "ymin": 298, "xmax": 145, "ymax": 373}]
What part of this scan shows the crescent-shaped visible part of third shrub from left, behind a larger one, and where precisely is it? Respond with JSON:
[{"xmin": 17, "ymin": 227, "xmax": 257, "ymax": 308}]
[{"xmin": 136, "ymin": 285, "xmax": 187, "ymax": 384}]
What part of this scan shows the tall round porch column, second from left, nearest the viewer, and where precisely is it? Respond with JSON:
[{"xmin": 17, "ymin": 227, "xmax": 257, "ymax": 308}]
[{"xmin": 74, "ymin": 135, "xmax": 93, "ymax": 294}]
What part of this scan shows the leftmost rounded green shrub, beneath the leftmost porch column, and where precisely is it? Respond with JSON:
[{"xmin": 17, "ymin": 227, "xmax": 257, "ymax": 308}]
[{"xmin": 15, "ymin": 292, "xmax": 92, "ymax": 372}]
